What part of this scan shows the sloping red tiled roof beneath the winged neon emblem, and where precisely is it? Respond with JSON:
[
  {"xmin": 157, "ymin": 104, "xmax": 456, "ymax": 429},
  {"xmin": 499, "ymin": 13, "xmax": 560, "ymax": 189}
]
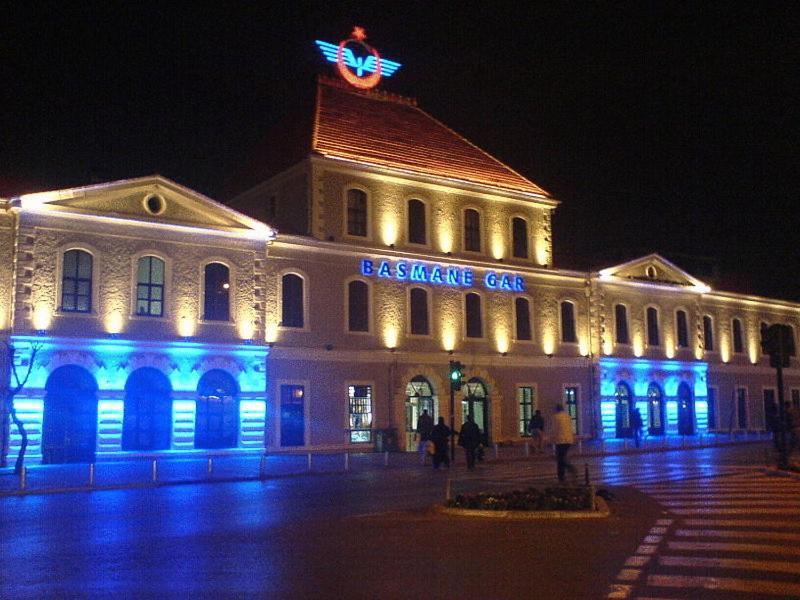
[{"xmin": 312, "ymin": 79, "xmax": 549, "ymax": 197}]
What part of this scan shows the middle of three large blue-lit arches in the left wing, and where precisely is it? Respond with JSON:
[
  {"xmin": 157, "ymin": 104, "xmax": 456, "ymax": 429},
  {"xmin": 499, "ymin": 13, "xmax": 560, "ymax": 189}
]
[{"xmin": 122, "ymin": 367, "xmax": 172, "ymax": 450}]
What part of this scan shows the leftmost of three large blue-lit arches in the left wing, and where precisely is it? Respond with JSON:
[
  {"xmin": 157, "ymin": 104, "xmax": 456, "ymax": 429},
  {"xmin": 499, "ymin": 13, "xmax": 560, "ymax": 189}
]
[{"xmin": 42, "ymin": 365, "xmax": 97, "ymax": 464}]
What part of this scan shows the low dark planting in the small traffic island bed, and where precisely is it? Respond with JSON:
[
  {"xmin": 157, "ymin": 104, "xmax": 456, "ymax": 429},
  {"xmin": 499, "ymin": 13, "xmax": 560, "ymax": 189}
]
[{"xmin": 446, "ymin": 487, "xmax": 594, "ymax": 511}]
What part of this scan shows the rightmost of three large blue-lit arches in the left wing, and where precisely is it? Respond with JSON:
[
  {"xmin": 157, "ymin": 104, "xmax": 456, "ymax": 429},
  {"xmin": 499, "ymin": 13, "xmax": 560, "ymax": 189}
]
[{"xmin": 194, "ymin": 369, "xmax": 239, "ymax": 449}]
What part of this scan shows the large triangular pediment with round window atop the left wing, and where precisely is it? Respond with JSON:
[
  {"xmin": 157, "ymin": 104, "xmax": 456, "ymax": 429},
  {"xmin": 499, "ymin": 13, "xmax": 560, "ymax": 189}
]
[{"xmin": 20, "ymin": 175, "xmax": 270, "ymax": 234}]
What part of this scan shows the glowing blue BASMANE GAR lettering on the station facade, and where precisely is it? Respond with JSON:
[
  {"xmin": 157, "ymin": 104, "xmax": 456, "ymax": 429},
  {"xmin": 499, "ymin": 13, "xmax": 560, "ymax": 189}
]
[{"xmin": 361, "ymin": 258, "xmax": 525, "ymax": 292}]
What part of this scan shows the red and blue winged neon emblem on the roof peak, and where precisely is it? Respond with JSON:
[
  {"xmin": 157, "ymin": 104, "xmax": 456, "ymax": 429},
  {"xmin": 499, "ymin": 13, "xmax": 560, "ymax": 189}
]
[{"xmin": 315, "ymin": 27, "xmax": 402, "ymax": 90}]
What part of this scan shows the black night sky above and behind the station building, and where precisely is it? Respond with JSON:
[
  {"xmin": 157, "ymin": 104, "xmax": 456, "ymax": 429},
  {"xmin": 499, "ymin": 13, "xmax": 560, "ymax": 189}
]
[{"xmin": 0, "ymin": 1, "xmax": 800, "ymax": 300}]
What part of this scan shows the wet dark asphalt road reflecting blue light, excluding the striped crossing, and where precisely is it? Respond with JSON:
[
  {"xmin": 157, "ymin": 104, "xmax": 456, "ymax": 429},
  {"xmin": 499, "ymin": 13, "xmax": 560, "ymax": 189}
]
[{"xmin": 0, "ymin": 446, "xmax": 776, "ymax": 599}]
